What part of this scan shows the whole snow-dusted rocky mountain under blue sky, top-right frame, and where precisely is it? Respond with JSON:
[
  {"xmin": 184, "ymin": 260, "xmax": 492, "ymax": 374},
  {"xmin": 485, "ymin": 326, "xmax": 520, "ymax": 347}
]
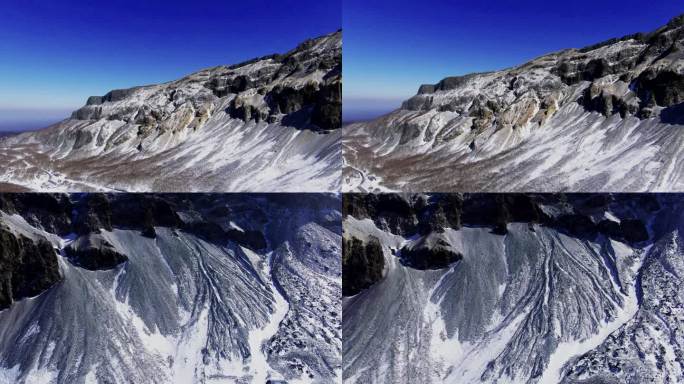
[{"xmin": 343, "ymin": 16, "xmax": 684, "ymax": 192}]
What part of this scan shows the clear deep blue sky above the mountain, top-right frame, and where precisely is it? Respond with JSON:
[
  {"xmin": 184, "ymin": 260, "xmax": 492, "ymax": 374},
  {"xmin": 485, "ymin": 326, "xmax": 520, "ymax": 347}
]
[{"xmin": 343, "ymin": 0, "xmax": 684, "ymax": 118}]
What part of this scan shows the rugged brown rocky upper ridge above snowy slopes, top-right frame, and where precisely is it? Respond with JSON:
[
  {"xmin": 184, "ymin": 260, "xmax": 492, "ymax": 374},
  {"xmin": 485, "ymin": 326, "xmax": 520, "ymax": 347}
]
[{"xmin": 402, "ymin": 16, "xmax": 684, "ymax": 136}]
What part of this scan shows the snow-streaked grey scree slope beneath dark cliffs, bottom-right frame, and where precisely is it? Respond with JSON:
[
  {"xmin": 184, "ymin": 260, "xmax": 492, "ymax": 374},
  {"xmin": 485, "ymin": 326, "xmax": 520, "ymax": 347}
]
[{"xmin": 343, "ymin": 195, "xmax": 684, "ymax": 384}]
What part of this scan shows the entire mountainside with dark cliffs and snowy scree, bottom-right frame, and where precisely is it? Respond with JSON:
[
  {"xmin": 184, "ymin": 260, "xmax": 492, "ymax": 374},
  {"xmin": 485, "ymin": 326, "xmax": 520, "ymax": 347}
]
[{"xmin": 342, "ymin": 194, "xmax": 684, "ymax": 384}]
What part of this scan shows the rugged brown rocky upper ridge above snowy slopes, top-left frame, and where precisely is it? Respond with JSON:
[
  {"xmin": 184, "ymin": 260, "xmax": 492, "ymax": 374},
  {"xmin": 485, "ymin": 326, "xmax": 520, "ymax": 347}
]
[{"xmin": 71, "ymin": 31, "xmax": 342, "ymax": 153}]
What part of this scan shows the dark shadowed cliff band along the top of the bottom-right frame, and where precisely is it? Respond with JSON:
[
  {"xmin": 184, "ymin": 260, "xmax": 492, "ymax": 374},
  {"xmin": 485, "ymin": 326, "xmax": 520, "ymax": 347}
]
[{"xmin": 343, "ymin": 193, "xmax": 660, "ymax": 242}]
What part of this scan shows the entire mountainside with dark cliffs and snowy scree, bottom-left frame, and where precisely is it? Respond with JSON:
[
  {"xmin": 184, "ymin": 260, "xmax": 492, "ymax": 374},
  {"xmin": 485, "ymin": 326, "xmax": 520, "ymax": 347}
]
[{"xmin": 0, "ymin": 194, "xmax": 342, "ymax": 384}]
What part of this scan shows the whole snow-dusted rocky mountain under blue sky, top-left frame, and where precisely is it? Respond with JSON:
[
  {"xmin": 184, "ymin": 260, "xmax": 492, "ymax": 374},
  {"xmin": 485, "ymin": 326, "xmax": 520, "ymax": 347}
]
[{"xmin": 0, "ymin": 31, "xmax": 342, "ymax": 192}]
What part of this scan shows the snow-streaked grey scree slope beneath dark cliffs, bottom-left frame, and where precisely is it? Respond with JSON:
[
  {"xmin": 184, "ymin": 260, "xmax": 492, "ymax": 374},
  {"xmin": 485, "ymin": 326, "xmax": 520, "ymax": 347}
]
[{"xmin": 0, "ymin": 194, "xmax": 342, "ymax": 384}]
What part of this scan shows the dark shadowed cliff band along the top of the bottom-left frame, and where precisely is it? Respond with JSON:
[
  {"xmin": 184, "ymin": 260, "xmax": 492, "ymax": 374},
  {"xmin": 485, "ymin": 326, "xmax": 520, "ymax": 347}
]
[{"xmin": 0, "ymin": 193, "xmax": 266, "ymax": 250}]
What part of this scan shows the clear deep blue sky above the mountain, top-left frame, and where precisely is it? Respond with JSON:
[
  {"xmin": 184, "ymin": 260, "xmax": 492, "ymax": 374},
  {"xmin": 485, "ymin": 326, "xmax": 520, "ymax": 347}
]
[{"xmin": 0, "ymin": 0, "xmax": 342, "ymax": 130}]
